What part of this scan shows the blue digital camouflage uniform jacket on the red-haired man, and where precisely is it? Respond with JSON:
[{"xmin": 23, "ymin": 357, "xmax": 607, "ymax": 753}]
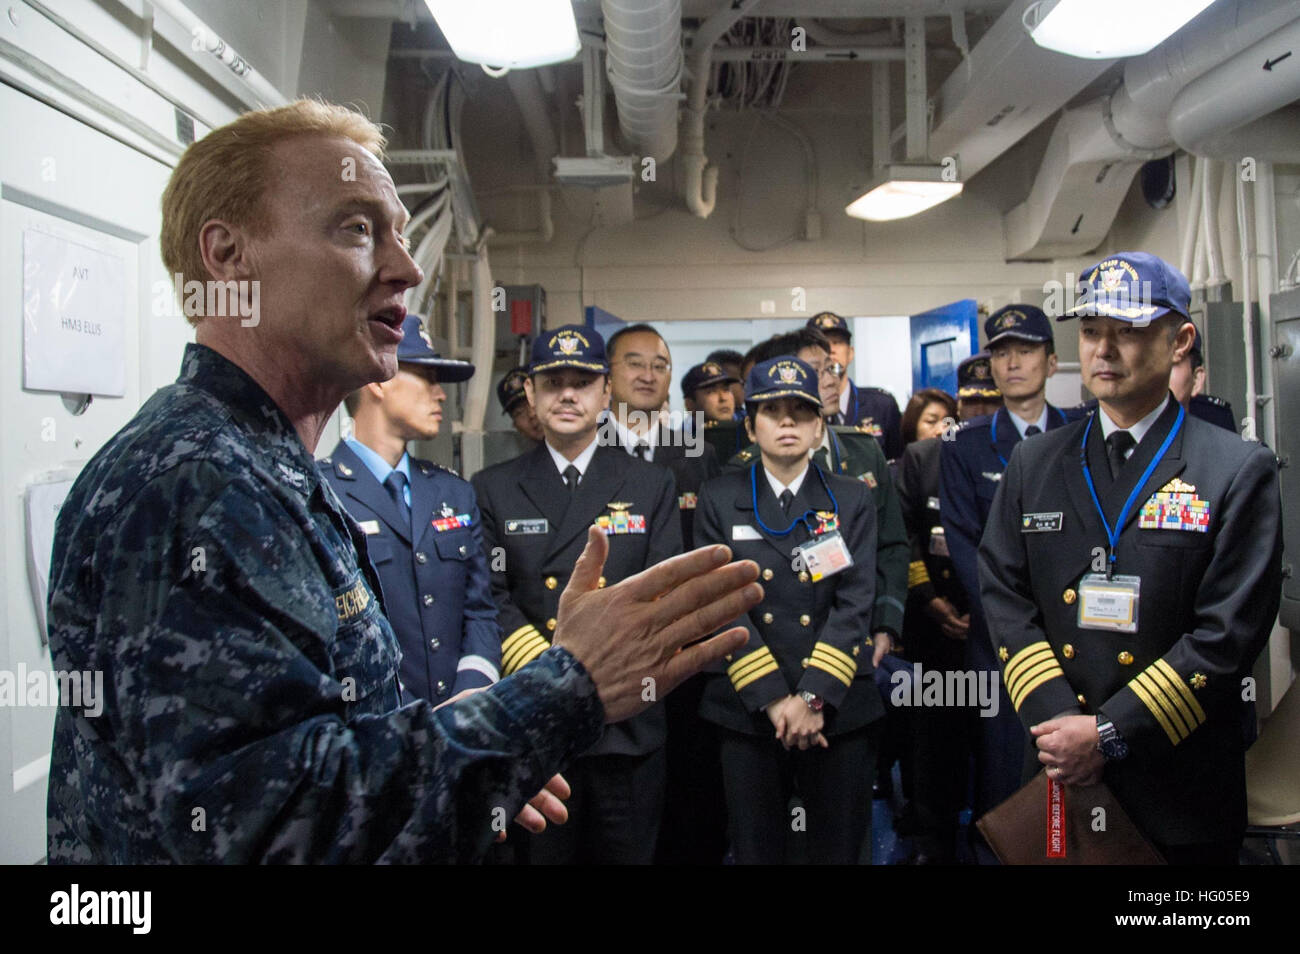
[{"xmin": 47, "ymin": 344, "xmax": 603, "ymax": 863}]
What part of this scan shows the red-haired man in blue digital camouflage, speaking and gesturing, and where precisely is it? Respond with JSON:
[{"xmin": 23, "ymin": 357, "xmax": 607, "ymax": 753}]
[{"xmin": 47, "ymin": 100, "xmax": 762, "ymax": 863}]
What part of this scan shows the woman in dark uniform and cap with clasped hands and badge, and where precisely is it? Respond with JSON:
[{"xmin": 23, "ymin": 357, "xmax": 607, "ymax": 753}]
[{"xmin": 696, "ymin": 356, "xmax": 884, "ymax": 864}]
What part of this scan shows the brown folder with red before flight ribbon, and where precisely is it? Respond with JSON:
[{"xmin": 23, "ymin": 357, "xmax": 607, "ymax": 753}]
[{"xmin": 975, "ymin": 772, "xmax": 1165, "ymax": 864}]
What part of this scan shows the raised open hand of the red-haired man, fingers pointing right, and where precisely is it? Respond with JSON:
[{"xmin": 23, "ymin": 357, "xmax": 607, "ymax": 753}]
[{"xmin": 554, "ymin": 526, "xmax": 763, "ymax": 723}]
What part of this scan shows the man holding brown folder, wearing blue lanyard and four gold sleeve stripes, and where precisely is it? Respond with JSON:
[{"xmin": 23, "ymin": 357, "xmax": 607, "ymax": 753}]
[{"xmin": 979, "ymin": 252, "xmax": 1282, "ymax": 864}]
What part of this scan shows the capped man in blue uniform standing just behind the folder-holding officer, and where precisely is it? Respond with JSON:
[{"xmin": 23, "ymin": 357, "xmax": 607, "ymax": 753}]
[{"xmin": 939, "ymin": 304, "xmax": 1067, "ymax": 831}]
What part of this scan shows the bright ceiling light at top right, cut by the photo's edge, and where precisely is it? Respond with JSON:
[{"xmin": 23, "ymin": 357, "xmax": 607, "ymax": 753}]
[{"xmin": 1023, "ymin": 0, "xmax": 1214, "ymax": 60}]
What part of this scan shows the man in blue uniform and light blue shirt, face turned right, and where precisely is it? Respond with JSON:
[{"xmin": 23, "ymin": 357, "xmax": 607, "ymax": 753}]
[{"xmin": 317, "ymin": 315, "xmax": 501, "ymax": 703}]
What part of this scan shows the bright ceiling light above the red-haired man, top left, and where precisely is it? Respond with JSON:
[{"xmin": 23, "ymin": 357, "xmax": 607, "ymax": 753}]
[{"xmin": 424, "ymin": 0, "xmax": 582, "ymax": 69}]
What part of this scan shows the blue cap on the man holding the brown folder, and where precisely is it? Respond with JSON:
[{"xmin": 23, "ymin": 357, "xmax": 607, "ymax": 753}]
[{"xmin": 1057, "ymin": 252, "xmax": 1192, "ymax": 322}]
